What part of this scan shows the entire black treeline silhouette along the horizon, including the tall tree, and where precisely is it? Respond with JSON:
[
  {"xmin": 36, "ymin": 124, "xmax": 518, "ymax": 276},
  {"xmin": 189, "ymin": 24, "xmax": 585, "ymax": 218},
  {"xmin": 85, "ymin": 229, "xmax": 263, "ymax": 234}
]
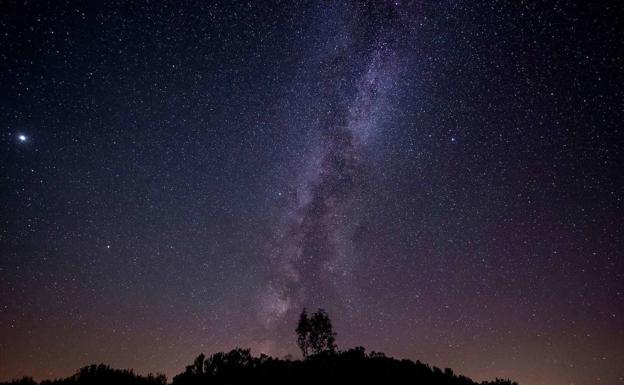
[{"xmin": 0, "ymin": 309, "xmax": 518, "ymax": 385}]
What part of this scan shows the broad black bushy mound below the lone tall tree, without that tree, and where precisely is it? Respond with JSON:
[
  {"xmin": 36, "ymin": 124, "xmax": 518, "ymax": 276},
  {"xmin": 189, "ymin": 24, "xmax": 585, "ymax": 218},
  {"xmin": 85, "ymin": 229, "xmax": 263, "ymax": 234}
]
[{"xmin": 167, "ymin": 347, "xmax": 517, "ymax": 385}]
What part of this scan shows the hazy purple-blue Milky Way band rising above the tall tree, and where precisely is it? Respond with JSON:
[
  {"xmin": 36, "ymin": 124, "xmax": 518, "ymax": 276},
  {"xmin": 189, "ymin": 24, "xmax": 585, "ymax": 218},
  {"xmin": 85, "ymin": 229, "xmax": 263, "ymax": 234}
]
[{"xmin": 260, "ymin": 2, "xmax": 399, "ymax": 328}]
